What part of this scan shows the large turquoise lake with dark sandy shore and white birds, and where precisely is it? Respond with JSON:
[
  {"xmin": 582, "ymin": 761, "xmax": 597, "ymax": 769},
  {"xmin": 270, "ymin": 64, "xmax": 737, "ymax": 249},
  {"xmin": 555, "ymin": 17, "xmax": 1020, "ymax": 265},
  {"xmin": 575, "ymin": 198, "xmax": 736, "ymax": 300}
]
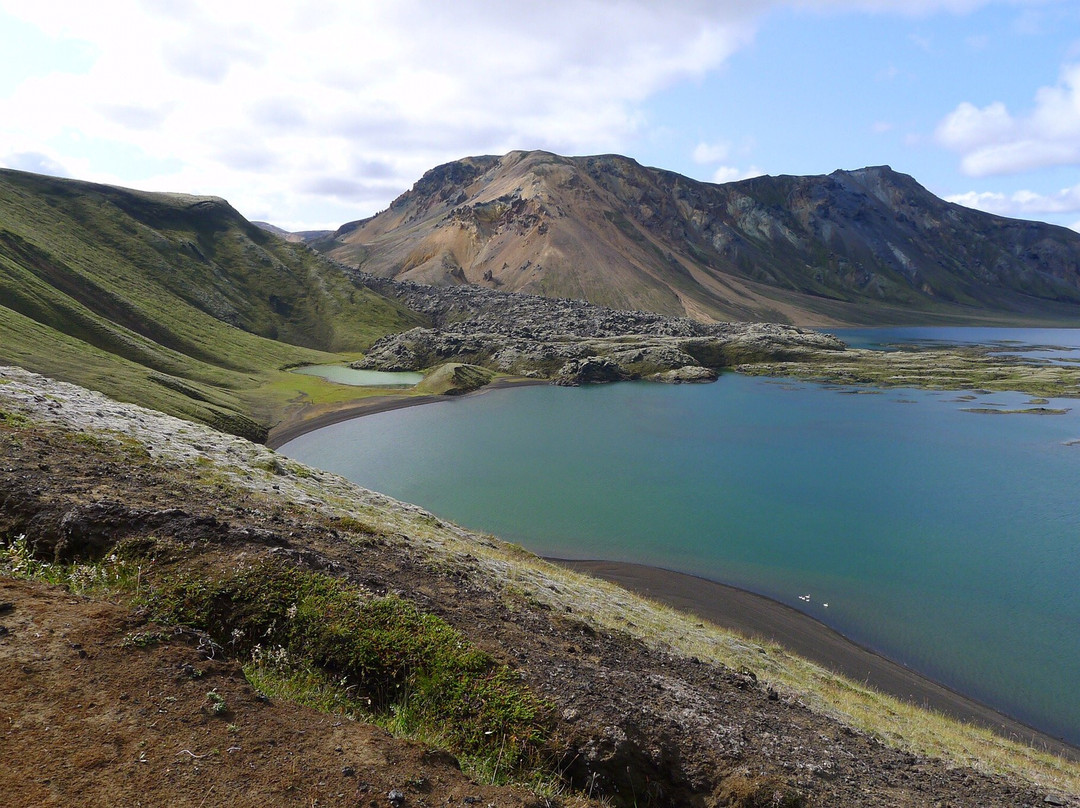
[{"xmin": 281, "ymin": 332, "xmax": 1080, "ymax": 743}]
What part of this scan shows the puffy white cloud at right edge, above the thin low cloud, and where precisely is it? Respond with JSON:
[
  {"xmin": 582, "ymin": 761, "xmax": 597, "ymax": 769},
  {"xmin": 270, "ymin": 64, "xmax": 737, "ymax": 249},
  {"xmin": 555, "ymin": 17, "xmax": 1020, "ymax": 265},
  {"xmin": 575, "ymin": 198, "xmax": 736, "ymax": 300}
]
[{"xmin": 935, "ymin": 64, "xmax": 1080, "ymax": 177}]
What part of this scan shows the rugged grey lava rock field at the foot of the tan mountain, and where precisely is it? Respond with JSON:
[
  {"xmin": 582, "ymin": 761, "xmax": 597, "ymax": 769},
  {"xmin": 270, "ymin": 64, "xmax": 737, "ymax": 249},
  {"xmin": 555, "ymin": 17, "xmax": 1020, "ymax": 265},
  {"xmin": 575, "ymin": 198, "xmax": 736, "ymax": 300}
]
[{"xmin": 354, "ymin": 273, "xmax": 845, "ymax": 385}]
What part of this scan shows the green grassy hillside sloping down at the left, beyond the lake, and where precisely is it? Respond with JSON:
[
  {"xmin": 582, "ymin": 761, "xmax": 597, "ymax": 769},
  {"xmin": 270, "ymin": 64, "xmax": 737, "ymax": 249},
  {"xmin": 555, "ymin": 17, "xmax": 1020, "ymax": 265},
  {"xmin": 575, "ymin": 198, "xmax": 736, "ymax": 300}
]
[{"xmin": 0, "ymin": 171, "xmax": 422, "ymax": 437}]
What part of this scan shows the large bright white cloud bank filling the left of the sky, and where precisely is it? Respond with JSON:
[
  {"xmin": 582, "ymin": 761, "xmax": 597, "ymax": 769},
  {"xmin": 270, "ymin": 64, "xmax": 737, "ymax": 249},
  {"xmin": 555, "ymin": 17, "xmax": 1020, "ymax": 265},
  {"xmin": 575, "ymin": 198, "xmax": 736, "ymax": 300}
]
[{"xmin": 0, "ymin": 0, "xmax": 1052, "ymax": 229}]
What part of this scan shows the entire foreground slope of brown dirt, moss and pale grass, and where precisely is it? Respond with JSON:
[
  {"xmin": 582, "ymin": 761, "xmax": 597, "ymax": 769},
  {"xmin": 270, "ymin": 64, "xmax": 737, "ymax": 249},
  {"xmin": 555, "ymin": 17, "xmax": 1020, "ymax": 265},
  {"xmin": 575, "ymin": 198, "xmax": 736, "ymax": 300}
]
[{"xmin": 0, "ymin": 367, "xmax": 1080, "ymax": 808}]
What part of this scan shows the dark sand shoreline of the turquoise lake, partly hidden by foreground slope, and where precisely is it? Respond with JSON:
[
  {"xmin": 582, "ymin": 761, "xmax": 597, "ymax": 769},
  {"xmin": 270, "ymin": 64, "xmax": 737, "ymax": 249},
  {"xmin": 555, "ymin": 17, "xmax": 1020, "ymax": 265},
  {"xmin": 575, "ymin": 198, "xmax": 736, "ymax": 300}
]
[{"xmin": 266, "ymin": 378, "xmax": 1080, "ymax": 762}]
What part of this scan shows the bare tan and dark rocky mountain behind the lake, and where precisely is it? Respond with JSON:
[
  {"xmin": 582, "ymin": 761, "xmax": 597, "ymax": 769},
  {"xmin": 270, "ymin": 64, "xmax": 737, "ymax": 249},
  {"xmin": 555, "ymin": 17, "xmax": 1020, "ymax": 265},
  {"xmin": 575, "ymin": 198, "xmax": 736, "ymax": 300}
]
[{"xmin": 311, "ymin": 151, "xmax": 1080, "ymax": 324}]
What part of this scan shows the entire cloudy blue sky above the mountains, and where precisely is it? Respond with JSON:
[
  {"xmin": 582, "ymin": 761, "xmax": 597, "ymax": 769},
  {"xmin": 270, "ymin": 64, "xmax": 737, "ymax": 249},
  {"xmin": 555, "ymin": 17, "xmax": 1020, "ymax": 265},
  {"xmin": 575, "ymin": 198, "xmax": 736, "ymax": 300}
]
[{"xmin": 0, "ymin": 0, "xmax": 1080, "ymax": 230}]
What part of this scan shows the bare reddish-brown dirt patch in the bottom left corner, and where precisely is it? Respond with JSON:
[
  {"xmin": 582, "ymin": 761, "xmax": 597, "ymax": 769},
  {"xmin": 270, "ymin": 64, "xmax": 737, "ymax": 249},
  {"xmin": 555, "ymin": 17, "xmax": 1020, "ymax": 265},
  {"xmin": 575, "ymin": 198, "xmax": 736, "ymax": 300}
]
[{"xmin": 0, "ymin": 579, "xmax": 539, "ymax": 808}]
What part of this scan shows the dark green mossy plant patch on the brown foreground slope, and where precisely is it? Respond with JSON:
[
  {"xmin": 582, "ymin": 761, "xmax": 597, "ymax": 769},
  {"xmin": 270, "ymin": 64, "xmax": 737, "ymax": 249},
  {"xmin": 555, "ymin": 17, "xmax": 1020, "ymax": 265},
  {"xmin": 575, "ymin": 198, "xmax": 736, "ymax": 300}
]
[{"xmin": 147, "ymin": 563, "xmax": 550, "ymax": 775}]
